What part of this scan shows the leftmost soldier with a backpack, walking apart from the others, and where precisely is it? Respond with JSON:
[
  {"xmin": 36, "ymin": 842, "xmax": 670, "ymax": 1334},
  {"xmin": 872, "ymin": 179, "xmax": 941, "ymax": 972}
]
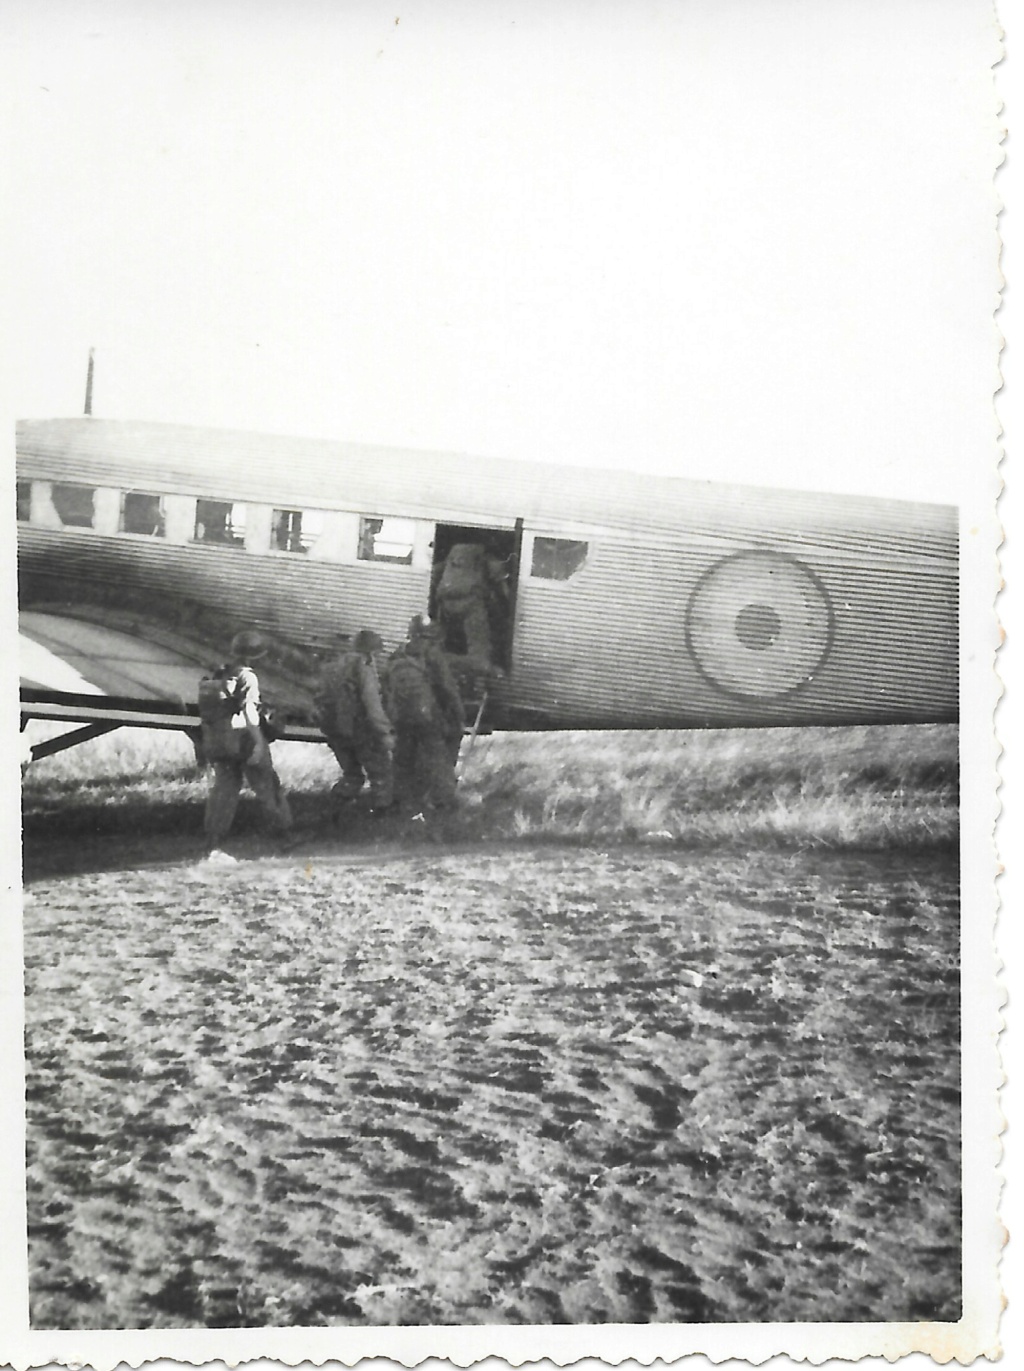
[{"xmin": 199, "ymin": 629, "xmax": 292, "ymax": 854}]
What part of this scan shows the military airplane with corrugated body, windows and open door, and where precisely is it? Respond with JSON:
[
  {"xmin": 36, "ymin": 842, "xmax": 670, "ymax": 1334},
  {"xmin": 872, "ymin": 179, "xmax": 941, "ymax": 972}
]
[{"xmin": 16, "ymin": 415, "xmax": 958, "ymax": 757}]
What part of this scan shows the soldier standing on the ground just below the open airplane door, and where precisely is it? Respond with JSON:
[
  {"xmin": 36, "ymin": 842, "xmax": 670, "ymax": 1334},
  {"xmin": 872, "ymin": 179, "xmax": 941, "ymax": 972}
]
[{"xmin": 387, "ymin": 614, "xmax": 465, "ymax": 809}]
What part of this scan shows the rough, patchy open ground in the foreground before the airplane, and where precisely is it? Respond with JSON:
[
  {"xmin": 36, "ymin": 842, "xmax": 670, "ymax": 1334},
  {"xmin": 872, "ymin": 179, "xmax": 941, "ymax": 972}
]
[{"xmin": 25, "ymin": 846, "xmax": 960, "ymax": 1328}]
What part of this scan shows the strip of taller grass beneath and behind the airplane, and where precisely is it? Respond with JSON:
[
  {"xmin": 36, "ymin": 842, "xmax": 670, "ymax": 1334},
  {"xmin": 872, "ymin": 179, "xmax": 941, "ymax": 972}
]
[{"xmin": 23, "ymin": 725, "xmax": 958, "ymax": 869}]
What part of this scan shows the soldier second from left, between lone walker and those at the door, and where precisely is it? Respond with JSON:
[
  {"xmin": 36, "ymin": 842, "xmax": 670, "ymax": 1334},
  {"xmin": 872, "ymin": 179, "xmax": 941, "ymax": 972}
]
[{"xmin": 314, "ymin": 628, "xmax": 395, "ymax": 814}]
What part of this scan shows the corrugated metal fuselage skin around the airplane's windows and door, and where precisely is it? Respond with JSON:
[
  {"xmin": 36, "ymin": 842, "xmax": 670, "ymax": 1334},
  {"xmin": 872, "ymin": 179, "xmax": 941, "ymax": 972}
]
[{"xmin": 18, "ymin": 420, "xmax": 958, "ymax": 728}]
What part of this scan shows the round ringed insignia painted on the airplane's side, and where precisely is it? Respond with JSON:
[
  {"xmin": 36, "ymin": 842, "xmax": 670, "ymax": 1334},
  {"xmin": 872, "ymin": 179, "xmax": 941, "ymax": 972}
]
[{"xmin": 687, "ymin": 551, "xmax": 833, "ymax": 699}]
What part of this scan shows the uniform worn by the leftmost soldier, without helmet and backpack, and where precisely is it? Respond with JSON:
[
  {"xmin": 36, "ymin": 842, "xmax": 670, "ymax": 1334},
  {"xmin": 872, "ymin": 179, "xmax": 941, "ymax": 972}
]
[{"xmin": 202, "ymin": 662, "xmax": 292, "ymax": 847}]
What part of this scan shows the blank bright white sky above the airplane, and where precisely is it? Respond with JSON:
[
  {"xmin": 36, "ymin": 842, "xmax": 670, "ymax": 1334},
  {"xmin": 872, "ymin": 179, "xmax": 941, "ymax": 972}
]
[{"xmin": 0, "ymin": 0, "xmax": 999, "ymax": 500}]
